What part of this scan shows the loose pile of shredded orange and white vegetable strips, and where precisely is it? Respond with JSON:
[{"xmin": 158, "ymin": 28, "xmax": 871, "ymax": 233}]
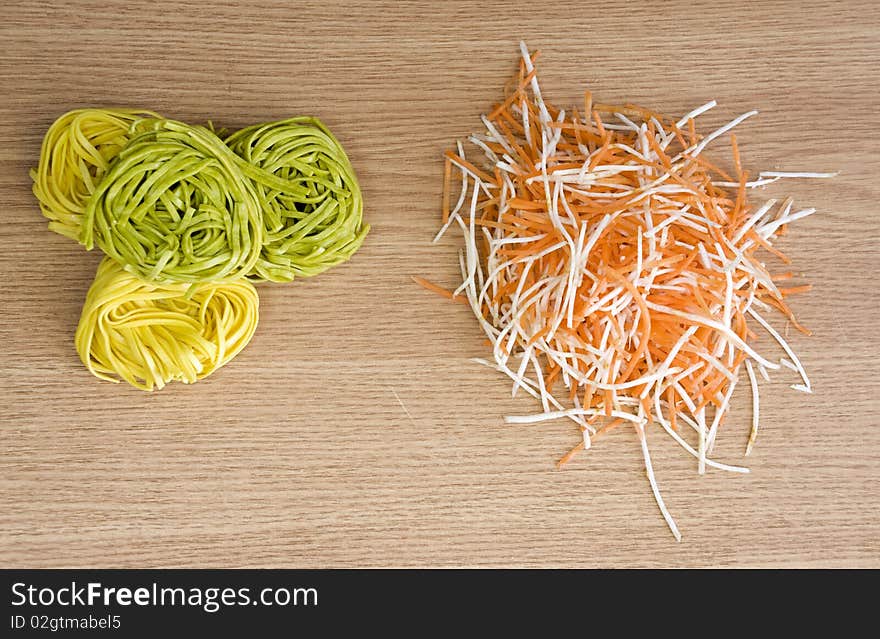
[{"xmin": 414, "ymin": 44, "xmax": 834, "ymax": 540}]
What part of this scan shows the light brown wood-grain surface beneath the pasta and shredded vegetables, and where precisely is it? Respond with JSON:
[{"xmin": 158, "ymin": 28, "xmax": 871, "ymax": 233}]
[{"xmin": 0, "ymin": 0, "xmax": 880, "ymax": 567}]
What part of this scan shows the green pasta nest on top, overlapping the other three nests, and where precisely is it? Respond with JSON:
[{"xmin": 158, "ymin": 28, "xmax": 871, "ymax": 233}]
[{"xmin": 80, "ymin": 120, "xmax": 263, "ymax": 282}]
